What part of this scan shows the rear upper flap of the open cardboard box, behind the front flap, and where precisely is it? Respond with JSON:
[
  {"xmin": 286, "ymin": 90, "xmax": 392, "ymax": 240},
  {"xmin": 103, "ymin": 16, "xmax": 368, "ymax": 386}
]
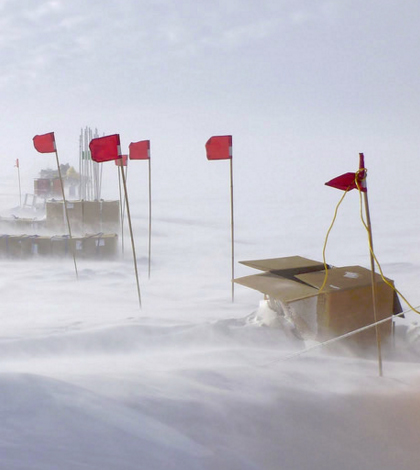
[{"xmin": 240, "ymin": 256, "xmax": 324, "ymax": 277}]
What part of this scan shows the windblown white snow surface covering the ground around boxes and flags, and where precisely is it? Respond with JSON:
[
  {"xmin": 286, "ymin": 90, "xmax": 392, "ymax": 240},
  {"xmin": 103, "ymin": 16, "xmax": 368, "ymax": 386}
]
[{"xmin": 0, "ymin": 173, "xmax": 420, "ymax": 470}]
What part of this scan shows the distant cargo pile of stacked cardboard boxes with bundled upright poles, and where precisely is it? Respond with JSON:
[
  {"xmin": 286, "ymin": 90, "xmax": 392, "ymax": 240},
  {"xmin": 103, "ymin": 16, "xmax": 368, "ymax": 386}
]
[{"xmin": 0, "ymin": 128, "xmax": 122, "ymax": 259}]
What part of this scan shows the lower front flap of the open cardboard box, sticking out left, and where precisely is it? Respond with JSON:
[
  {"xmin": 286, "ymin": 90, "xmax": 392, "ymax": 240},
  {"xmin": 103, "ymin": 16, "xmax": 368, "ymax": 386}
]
[{"xmin": 235, "ymin": 273, "xmax": 318, "ymax": 303}]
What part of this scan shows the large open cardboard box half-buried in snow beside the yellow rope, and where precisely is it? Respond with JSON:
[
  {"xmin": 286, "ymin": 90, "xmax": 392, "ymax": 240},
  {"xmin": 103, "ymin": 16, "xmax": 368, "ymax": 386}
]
[{"xmin": 235, "ymin": 256, "xmax": 402, "ymax": 346}]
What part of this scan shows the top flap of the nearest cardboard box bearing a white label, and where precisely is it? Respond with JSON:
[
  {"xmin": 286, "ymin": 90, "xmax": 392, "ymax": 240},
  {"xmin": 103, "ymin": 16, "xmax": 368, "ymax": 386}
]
[{"xmin": 296, "ymin": 266, "xmax": 383, "ymax": 292}]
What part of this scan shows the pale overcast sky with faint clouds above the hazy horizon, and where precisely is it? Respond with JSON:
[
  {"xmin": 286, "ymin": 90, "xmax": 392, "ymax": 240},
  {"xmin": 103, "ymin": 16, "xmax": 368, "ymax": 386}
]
[{"xmin": 0, "ymin": 0, "xmax": 420, "ymax": 202}]
